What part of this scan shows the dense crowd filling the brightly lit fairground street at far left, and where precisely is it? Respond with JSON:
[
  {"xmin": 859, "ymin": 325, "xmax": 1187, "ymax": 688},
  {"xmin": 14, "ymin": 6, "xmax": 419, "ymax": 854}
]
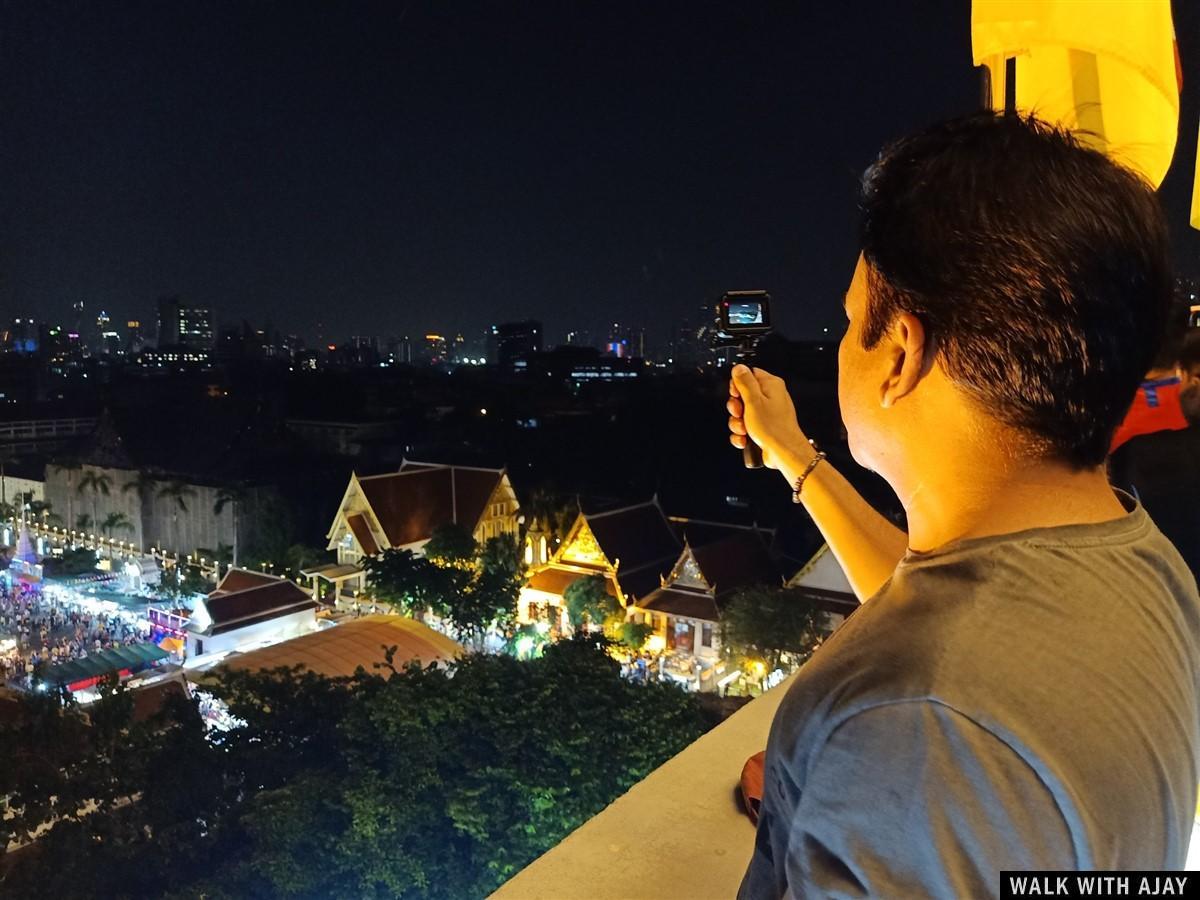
[{"xmin": 0, "ymin": 581, "xmax": 149, "ymax": 682}]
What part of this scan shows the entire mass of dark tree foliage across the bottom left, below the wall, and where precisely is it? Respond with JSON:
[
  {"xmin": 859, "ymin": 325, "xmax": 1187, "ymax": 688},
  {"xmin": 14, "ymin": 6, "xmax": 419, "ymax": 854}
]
[{"xmin": 0, "ymin": 638, "xmax": 702, "ymax": 900}]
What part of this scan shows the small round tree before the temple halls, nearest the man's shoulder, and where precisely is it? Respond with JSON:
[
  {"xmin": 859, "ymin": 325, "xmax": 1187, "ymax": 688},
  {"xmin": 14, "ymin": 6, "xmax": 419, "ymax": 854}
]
[{"xmin": 720, "ymin": 587, "xmax": 827, "ymax": 672}]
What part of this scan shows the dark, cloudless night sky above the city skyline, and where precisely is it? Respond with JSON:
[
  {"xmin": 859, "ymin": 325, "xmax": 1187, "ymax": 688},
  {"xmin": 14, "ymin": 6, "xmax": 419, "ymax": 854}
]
[{"xmin": 0, "ymin": 0, "xmax": 1200, "ymax": 343}]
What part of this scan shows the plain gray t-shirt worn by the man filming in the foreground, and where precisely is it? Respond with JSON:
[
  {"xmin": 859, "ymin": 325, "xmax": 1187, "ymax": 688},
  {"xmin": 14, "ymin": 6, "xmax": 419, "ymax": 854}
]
[{"xmin": 739, "ymin": 496, "xmax": 1200, "ymax": 900}]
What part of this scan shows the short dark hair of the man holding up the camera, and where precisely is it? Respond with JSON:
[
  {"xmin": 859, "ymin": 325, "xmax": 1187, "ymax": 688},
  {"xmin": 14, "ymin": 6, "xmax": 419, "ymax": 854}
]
[{"xmin": 860, "ymin": 113, "xmax": 1171, "ymax": 468}]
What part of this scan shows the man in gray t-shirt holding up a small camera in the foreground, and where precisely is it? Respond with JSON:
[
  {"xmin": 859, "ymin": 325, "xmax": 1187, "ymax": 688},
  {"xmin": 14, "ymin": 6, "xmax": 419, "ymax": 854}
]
[{"xmin": 728, "ymin": 113, "xmax": 1200, "ymax": 899}]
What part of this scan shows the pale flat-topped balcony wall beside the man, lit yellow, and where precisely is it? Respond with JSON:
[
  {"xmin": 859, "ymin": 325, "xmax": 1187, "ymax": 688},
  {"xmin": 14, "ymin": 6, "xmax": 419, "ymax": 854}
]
[{"xmin": 492, "ymin": 680, "xmax": 790, "ymax": 900}]
